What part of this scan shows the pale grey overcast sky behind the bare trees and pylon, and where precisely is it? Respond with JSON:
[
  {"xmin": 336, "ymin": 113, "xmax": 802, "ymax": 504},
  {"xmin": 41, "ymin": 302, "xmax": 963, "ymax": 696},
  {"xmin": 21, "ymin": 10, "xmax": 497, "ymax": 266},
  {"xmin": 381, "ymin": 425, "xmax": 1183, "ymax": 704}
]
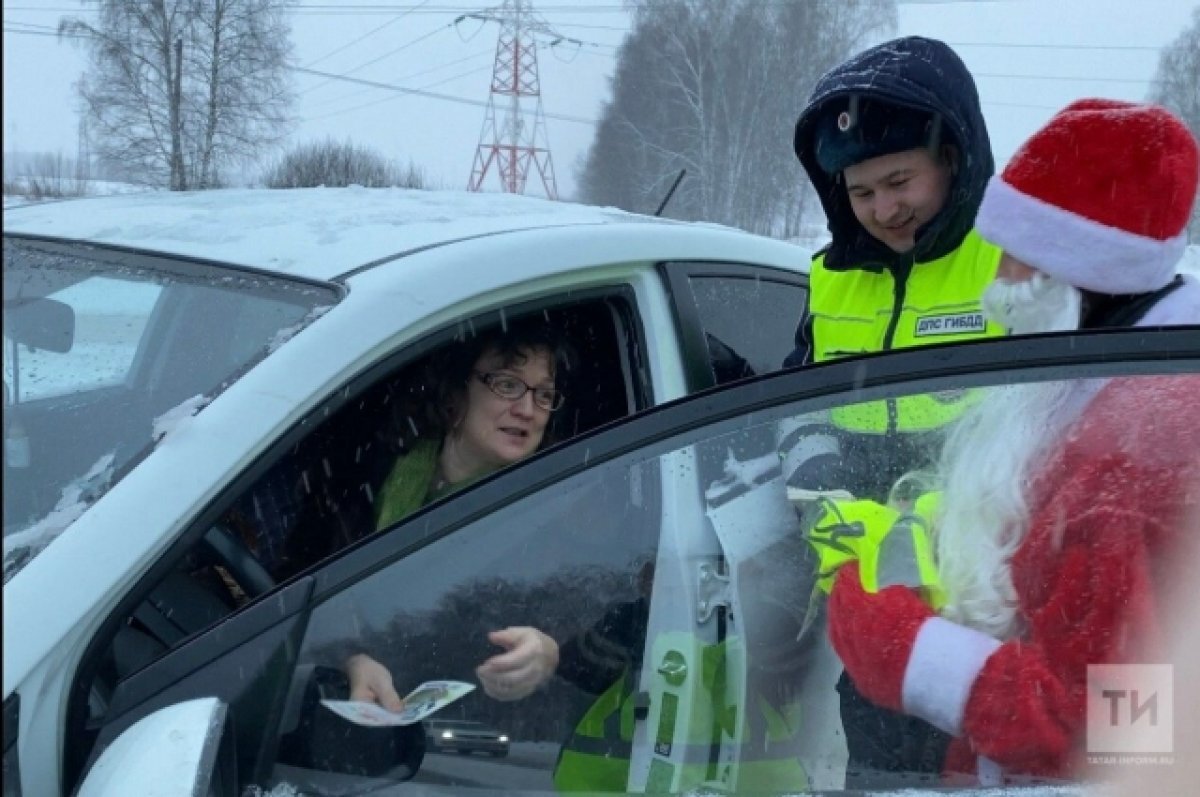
[{"xmin": 2, "ymin": 0, "xmax": 1196, "ymax": 197}]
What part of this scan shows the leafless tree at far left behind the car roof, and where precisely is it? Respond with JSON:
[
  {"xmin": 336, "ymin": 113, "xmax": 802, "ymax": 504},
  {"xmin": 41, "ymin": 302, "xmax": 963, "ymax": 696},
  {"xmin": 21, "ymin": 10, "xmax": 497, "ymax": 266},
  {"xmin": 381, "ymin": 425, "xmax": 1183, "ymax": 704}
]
[{"xmin": 59, "ymin": 0, "xmax": 292, "ymax": 191}]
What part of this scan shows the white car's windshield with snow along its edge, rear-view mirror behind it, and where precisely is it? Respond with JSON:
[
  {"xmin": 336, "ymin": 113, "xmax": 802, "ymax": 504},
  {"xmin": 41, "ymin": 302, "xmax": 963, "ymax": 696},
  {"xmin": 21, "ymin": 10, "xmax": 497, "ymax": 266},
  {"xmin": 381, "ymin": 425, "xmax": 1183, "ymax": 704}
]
[{"xmin": 2, "ymin": 238, "xmax": 338, "ymax": 581}]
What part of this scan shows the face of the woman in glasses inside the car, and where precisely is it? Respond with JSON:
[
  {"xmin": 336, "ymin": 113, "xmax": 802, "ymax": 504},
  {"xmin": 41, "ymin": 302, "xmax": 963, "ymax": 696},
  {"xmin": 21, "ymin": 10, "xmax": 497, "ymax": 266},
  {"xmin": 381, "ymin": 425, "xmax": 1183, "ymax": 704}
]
[{"xmin": 455, "ymin": 349, "xmax": 554, "ymax": 473}]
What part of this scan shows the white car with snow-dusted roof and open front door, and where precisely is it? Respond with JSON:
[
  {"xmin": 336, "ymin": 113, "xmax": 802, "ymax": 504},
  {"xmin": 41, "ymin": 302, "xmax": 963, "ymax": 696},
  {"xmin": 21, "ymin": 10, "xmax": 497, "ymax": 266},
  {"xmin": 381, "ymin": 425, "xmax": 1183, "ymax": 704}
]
[{"xmin": 4, "ymin": 190, "xmax": 1200, "ymax": 797}]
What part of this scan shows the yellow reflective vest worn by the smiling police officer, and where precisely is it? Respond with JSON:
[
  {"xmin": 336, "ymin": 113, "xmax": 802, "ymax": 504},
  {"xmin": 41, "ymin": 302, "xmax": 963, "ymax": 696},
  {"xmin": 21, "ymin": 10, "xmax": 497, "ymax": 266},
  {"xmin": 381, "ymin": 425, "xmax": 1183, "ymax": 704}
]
[{"xmin": 809, "ymin": 229, "xmax": 1004, "ymax": 435}]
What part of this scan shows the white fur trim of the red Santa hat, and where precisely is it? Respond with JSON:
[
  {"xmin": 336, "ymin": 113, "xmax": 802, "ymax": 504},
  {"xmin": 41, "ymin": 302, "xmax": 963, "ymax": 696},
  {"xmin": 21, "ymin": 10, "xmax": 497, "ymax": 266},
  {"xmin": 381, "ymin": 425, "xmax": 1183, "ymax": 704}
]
[{"xmin": 976, "ymin": 176, "xmax": 1187, "ymax": 294}]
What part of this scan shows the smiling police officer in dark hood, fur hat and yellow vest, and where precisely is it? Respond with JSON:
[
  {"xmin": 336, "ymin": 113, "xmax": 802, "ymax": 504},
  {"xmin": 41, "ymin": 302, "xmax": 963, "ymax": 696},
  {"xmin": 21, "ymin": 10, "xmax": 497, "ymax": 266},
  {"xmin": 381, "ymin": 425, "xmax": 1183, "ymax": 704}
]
[{"xmin": 780, "ymin": 36, "xmax": 1004, "ymax": 787}]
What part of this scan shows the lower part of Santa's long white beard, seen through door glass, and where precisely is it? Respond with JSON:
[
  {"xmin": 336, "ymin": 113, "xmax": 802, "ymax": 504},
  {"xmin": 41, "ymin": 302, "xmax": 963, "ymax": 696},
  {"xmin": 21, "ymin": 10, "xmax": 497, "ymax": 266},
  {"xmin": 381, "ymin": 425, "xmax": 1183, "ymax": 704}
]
[{"xmin": 935, "ymin": 380, "xmax": 1088, "ymax": 640}]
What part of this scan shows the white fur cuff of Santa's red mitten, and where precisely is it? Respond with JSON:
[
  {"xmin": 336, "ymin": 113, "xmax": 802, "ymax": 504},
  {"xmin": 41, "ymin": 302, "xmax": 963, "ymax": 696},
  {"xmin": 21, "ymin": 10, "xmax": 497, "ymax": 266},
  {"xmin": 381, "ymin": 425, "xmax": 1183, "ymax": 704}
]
[{"xmin": 901, "ymin": 617, "xmax": 1000, "ymax": 736}]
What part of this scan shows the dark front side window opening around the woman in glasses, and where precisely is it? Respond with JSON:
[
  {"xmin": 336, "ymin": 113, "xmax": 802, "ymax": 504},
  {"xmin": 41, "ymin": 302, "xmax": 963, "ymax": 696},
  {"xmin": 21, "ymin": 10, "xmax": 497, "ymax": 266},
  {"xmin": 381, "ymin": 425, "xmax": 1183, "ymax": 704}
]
[{"xmin": 84, "ymin": 290, "xmax": 648, "ymax": 696}]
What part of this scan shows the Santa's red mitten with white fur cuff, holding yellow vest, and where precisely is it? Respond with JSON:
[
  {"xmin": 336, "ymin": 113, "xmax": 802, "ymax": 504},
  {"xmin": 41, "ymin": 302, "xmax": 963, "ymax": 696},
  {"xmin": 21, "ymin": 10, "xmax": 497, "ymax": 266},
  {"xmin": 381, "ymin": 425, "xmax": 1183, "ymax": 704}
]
[{"xmin": 828, "ymin": 562, "xmax": 1000, "ymax": 736}]
